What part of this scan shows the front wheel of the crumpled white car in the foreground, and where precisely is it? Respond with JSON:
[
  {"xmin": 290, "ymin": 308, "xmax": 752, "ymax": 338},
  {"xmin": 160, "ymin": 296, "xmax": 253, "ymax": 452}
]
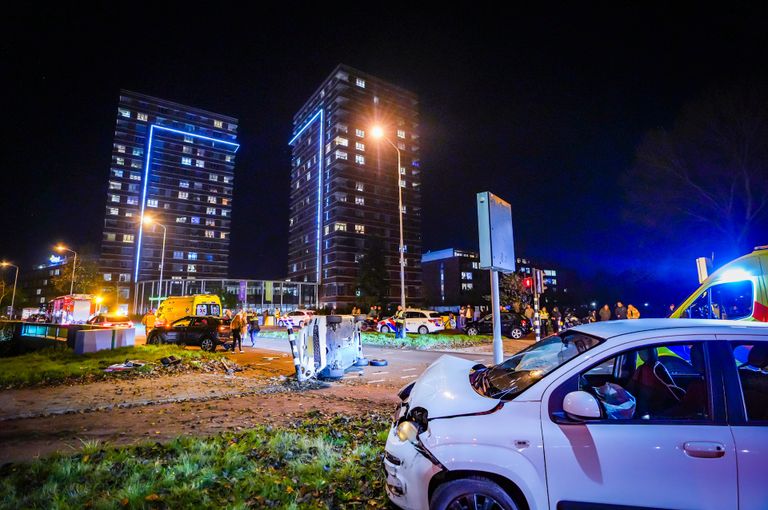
[{"xmin": 429, "ymin": 476, "xmax": 519, "ymax": 510}]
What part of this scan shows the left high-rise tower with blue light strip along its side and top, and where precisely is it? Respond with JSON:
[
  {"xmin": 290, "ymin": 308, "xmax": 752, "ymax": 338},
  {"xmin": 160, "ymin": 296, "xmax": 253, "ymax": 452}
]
[{"xmin": 101, "ymin": 90, "xmax": 238, "ymax": 300}]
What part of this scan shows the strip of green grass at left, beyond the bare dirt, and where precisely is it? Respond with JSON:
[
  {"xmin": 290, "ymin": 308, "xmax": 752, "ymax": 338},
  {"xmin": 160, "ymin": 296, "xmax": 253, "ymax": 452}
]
[{"xmin": 0, "ymin": 345, "xmax": 222, "ymax": 387}]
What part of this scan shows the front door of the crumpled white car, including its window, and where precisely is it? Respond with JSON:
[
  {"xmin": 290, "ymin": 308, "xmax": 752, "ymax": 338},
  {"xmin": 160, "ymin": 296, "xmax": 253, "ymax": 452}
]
[{"xmin": 541, "ymin": 335, "xmax": 737, "ymax": 510}]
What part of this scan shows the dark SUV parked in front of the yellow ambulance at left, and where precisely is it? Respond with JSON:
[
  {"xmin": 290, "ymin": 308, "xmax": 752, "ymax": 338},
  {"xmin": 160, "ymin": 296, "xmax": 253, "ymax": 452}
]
[{"xmin": 147, "ymin": 316, "xmax": 231, "ymax": 352}]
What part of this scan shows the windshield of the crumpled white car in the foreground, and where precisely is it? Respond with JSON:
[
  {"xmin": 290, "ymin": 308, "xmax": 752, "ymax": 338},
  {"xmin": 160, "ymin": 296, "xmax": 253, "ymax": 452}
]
[{"xmin": 470, "ymin": 331, "xmax": 602, "ymax": 400}]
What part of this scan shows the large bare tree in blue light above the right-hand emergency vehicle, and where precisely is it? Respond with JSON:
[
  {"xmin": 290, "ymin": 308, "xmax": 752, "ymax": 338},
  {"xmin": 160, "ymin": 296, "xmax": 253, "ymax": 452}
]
[{"xmin": 623, "ymin": 85, "xmax": 768, "ymax": 252}]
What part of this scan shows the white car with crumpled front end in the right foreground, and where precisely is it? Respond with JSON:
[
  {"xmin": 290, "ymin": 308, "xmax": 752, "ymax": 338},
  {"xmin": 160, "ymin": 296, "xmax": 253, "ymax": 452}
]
[{"xmin": 384, "ymin": 319, "xmax": 768, "ymax": 510}]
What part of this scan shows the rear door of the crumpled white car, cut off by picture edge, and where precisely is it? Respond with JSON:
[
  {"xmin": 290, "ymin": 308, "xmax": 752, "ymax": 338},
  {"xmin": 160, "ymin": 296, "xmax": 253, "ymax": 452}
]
[{"xmin": 717, "ymin": 335, "xmax": 768, "ymax": 510}]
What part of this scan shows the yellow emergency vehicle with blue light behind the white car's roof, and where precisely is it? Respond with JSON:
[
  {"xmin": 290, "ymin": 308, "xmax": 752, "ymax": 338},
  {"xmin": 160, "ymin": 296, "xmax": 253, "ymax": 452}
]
[{"xmin": 670, "ymin": 245, "xmax": 768, "ymax": 322}]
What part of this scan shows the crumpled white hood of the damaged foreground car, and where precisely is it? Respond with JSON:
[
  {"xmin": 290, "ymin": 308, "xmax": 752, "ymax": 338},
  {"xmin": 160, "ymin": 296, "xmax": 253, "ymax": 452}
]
[{"xmin": 409, "ymin": 355, "xmax": 499, "ymax": 419}]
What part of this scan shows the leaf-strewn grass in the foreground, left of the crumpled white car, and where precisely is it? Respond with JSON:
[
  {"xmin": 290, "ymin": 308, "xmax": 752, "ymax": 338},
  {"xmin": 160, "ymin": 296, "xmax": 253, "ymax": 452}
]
[{"xmin": 0, "ymin": 412, "xmax": 388, "ymax": 509}]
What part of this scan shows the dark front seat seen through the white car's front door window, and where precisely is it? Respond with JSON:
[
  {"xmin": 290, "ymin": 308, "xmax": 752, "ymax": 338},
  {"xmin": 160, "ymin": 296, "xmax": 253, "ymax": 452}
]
[{"xmin": 627, "ymin": 348, "xmax": 685, "ymax": 417}]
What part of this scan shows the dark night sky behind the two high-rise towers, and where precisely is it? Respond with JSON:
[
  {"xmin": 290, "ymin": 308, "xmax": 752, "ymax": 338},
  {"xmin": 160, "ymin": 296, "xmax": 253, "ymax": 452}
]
[{"xmin": 0, "ymin": 3, "xmax": 768, "ymax": 306}]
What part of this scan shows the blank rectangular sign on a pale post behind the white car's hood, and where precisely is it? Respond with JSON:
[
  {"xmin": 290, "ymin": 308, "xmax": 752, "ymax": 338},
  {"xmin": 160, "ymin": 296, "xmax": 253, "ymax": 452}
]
[{"xmin": 477, "ymin": 191, "xmax": 515, "ymax": 364}]
